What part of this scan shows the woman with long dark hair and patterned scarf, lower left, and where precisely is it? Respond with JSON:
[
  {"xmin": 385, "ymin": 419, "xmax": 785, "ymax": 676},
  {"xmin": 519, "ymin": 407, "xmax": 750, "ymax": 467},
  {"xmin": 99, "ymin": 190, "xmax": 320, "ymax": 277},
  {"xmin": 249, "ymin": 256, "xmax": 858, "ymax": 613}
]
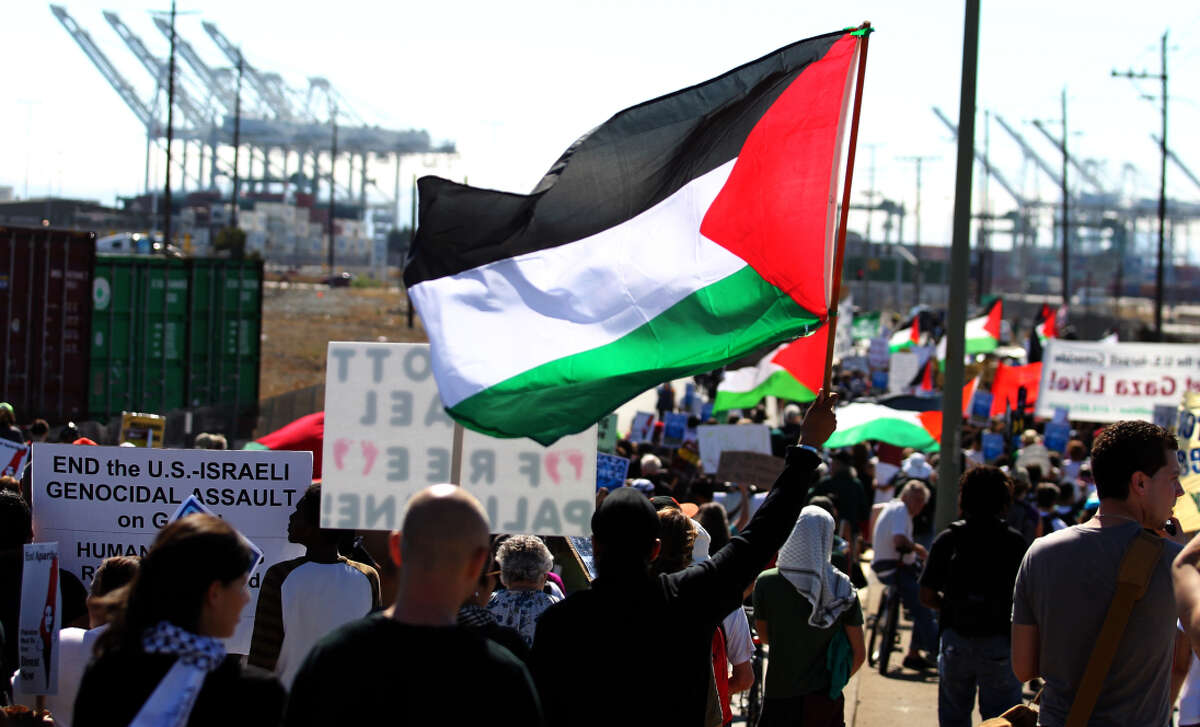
[{"xmin": 74, "ymin": 515, "xmax": 286, "ymax": 727}]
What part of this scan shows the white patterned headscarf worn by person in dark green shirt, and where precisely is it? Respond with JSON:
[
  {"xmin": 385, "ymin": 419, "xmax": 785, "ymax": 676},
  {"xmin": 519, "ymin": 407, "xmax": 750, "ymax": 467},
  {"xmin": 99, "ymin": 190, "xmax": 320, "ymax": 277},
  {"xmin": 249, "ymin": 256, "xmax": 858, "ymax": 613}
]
[{"xmin": 779, "ymin": 505, "xmax": 856, "ymax": 629}]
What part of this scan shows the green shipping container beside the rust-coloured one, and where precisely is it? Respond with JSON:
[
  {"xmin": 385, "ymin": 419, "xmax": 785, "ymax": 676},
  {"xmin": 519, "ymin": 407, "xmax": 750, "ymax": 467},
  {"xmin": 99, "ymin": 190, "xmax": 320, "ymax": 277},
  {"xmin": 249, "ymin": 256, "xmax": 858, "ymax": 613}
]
[{"xmin": 89, "ymin": 254, "xmax": 263, "ymax": 435}]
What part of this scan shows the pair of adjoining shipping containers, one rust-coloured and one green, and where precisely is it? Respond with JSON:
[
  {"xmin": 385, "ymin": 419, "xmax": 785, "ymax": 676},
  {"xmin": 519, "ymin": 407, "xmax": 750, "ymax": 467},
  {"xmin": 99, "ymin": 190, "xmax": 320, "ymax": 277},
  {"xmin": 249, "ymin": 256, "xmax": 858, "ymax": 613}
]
[{"xmin": 0, "ymin": 227, "xmax": 263, "ymax": 439}]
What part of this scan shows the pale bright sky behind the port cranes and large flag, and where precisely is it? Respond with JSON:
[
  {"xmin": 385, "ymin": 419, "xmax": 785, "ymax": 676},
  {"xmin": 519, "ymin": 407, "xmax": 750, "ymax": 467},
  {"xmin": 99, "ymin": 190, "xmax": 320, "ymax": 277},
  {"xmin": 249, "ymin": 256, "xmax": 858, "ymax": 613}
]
[{"xmin": 0, "ymin": 0, "xmax": 1200, "ymax": 249}]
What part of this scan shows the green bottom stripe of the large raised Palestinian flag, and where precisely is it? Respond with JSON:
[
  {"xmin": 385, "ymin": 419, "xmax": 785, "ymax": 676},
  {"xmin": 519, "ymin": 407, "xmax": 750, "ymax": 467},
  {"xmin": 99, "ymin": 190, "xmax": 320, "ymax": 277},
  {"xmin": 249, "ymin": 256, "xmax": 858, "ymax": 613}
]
[{"xmin": 448, "ymin": 265, "xmax": 821, "ymax": 445}]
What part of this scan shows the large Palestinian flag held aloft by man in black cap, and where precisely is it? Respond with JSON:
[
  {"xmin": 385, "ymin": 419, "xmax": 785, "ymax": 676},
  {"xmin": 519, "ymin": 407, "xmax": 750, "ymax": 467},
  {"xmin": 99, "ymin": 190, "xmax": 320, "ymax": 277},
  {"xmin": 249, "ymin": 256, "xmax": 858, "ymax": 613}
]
[{"xmin": 404, "ymin": 30, "xmax": 863, "ymax": 444}]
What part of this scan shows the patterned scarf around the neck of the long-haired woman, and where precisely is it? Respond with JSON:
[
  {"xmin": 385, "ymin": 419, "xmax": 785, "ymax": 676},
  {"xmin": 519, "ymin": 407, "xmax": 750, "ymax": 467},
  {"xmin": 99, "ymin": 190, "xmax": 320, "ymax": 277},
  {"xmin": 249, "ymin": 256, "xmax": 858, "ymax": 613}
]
[{"xmin": 130, "ymin": 621, "xmax": 226, "ymax": 727}]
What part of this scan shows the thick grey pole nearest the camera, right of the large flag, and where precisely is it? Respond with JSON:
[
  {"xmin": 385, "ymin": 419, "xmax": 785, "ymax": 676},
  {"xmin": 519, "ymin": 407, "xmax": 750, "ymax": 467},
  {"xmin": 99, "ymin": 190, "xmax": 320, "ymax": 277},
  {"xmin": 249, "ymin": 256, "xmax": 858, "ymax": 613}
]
[{"xmin": 934, "ymin": 0, "xmax": 979, "ymax": 531}]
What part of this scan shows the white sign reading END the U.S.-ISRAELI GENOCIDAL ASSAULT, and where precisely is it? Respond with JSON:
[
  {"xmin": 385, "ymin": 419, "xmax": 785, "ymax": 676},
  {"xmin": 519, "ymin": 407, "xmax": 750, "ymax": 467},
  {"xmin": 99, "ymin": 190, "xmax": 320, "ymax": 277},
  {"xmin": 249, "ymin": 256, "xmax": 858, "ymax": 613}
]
[{"xmin": 32, "ymin": 444, "xmax": 312, "ymax": 654}]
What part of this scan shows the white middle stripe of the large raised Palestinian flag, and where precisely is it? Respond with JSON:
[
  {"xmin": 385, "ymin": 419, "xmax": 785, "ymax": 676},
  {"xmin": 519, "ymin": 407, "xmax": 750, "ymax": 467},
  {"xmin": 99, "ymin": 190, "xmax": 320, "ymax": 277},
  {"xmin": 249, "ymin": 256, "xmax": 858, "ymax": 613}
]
[{"xmin": 409, "ymin": 158, "xmax": 746, "ymax": 407}]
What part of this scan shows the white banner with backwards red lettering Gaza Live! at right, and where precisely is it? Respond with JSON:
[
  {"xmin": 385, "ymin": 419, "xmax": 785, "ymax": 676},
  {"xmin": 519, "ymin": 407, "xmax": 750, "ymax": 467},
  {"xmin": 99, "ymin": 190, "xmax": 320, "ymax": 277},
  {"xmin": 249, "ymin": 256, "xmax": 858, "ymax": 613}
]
[{"xmin": 1037, "ymin": 338, "xmax": 1200, "ymax": 422}]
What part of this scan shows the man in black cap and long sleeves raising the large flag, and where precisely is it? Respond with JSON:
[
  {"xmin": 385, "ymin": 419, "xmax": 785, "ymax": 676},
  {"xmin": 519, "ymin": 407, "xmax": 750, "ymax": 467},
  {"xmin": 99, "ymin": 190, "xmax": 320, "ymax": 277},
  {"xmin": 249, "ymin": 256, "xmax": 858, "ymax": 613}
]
[{"xmin": 532, "ymin": 391, "xmax": 838, "ymax": 727}]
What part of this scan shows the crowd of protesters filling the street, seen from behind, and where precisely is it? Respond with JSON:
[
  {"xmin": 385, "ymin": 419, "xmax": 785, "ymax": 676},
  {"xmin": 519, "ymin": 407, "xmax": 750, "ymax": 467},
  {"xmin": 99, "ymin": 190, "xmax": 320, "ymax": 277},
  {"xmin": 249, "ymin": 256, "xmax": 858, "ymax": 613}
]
[{"xmin": 0, "ymin": 373, "xmax": 1200, "ymax": 727}]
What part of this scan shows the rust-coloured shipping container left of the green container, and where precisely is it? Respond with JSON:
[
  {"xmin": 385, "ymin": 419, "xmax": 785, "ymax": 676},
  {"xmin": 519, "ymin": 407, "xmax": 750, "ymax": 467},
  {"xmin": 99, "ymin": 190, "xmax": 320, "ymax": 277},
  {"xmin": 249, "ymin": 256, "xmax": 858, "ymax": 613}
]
[{"xmin": 0, "ymin": 227, "xmax": 96, "ymax": 425}]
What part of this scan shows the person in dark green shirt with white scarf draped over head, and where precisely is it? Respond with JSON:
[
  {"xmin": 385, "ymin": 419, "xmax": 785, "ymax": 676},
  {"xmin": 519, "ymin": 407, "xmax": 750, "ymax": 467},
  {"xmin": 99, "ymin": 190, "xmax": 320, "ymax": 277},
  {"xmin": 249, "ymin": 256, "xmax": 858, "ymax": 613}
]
[{"xmin": 754, "ymin": 505, "xmax": 866, "ymax": 727}]
